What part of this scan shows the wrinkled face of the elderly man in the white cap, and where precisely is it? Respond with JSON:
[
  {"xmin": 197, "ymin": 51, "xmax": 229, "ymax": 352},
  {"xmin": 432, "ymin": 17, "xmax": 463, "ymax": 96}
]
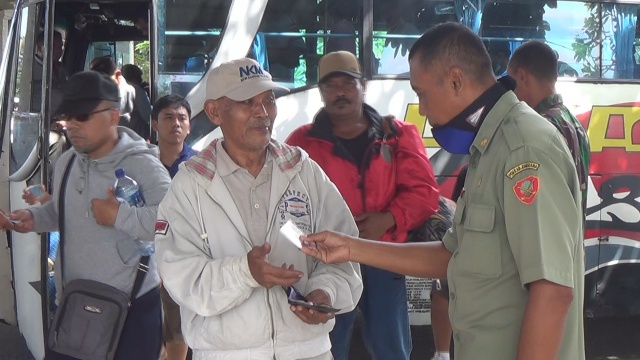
[{"xmin": 205, "ymin": 90, "xmax": 278, "ymax": 152}]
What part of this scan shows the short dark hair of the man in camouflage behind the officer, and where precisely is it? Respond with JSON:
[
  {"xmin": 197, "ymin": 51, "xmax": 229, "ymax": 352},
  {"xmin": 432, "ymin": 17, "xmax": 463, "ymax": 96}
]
[{"xmin": 509, "ymin": 40, "xmax": 558, "ymax": 82}]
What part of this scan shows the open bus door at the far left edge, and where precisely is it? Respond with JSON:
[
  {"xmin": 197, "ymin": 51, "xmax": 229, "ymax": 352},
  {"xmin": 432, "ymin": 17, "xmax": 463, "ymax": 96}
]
[{"xmin": 2, "ymin": 1, "xmax": 53, "ymax": 358}]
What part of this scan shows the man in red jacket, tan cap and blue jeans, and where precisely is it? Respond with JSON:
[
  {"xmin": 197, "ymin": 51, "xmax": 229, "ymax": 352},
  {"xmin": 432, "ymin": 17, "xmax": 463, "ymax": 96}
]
[{"xmin": 287, "ymin": 51, "xmax": 438, "ymax": 360}]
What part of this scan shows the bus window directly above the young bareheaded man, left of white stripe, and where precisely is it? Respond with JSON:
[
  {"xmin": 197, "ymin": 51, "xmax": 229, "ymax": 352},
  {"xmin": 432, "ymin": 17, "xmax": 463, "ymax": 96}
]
[{"xmin": 157, "ymin": 0, "xmax": 231, "ymax": 97}]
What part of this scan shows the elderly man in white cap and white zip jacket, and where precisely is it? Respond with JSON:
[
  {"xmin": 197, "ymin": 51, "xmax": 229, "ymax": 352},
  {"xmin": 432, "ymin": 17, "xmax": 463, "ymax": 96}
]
[{"xmin": 156, "ymin": 58, "xmax": 362, "ymax": 360}]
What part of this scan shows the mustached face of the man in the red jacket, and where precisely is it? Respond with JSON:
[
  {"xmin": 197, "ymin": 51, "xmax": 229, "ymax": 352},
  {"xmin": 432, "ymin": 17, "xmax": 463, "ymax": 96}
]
[{"xmin": 318, "ymin": 74, "xmax": 364, "ymax": 116}]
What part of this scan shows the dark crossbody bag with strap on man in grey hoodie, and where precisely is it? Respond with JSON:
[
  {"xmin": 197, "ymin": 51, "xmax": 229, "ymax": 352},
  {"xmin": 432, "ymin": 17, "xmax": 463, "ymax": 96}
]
[{"xmin": 48, "ymin": 154, "xmax": 149, "ymax": 360}]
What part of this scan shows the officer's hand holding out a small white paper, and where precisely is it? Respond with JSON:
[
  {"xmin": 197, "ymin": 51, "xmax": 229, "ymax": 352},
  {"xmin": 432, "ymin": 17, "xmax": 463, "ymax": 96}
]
[{"xmin": 300, "ymin": 231, "xmax": 351, "ymax": 264}]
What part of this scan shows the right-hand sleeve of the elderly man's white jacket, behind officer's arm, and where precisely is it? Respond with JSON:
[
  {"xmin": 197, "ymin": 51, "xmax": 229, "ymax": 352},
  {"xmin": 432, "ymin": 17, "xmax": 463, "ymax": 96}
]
[{"xmin": 302, "ymin": 160, "xmax": 362, "ymax": 313}]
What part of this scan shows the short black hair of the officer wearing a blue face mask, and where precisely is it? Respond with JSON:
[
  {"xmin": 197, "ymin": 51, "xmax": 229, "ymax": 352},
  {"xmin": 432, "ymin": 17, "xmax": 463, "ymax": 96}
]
[{"xmin": 409, "ymin": 22, "xmax": 493, "ymax": 81}]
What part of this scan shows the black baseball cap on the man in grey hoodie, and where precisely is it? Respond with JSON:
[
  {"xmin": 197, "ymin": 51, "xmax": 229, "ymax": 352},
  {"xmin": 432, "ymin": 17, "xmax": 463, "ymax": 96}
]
[{"xmin": 54, "ymin": 71, "xmax": 120, "ymax": 115}]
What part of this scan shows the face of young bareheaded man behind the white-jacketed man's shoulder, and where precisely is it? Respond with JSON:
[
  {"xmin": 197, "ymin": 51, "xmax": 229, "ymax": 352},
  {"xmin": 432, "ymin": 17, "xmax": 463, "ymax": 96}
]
[{"xmin": 151, "ymin": 105, "xmax": 191, "ymax": 145}]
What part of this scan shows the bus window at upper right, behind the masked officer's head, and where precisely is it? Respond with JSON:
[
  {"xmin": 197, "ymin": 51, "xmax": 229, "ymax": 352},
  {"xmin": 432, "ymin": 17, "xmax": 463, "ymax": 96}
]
[{"xmin": 479, "ymin": 0, "xmax": 640, "ymax": 79}]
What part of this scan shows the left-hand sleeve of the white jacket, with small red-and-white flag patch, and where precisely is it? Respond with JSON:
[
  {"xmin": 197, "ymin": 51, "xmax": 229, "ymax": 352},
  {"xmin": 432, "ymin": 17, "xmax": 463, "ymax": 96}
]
[{"xmin": 155, "ymin": 171, "xmax": 260, "ymax": 316}]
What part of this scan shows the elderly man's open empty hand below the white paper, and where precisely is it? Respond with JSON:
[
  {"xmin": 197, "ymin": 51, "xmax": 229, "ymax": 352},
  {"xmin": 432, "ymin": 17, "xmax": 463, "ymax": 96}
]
[{"xmin": 247, "ymin": 243, "xmax": 304, "ymax": 289}]
